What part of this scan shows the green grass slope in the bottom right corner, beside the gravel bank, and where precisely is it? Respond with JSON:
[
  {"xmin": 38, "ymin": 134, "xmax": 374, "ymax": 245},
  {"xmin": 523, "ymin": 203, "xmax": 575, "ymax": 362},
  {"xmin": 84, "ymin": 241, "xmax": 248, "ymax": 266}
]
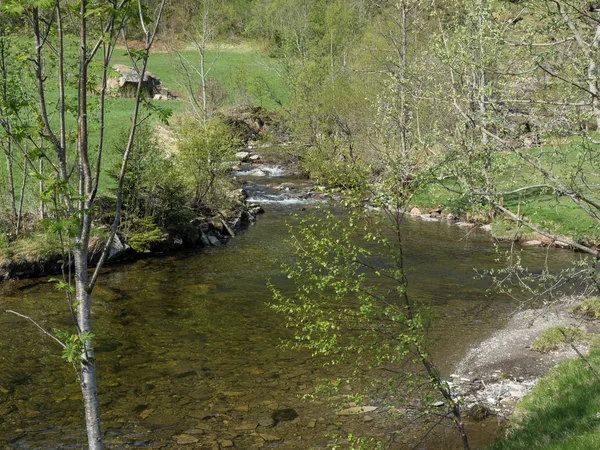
[{"xmin": 493, "ymin": 350, "xmax": 600, "ymax": 450}]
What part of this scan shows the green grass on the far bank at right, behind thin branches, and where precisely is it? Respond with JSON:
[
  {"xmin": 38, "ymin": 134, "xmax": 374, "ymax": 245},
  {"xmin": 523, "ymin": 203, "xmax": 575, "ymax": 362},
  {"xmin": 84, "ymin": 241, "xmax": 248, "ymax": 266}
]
[{"xmin": 414, "ymin": 138, "xmax": 600, "ymax": 244}]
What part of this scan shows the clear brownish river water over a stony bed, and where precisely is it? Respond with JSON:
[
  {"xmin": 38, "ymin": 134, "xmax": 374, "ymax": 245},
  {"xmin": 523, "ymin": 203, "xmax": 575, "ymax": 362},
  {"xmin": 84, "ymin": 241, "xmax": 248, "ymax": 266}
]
[{"xmin": 0, "ymin": 170, "xmax": 573, "ymax": 449}]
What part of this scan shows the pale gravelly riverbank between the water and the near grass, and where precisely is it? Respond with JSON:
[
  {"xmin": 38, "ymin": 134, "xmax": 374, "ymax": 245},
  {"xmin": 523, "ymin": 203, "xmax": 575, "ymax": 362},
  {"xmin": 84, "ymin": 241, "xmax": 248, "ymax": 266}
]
[{"xmin": 449, "ymin": 299, "xmax": 600, "ymax": 419}]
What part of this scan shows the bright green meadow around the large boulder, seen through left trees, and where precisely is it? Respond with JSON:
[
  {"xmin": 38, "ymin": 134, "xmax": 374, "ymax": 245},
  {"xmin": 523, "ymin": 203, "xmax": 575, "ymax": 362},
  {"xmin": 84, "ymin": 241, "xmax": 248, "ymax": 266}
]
[{"xmin": 0, "ymin": 43, "xmax": 287, "ymax": 210}]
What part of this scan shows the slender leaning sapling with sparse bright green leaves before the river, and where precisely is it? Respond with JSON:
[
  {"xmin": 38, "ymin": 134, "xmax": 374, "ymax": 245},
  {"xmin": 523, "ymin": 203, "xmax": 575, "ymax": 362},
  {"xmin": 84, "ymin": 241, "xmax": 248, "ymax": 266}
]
[{"xmin": 270, "ymin": 165, "xmax": 468, "ymax": 448}]
